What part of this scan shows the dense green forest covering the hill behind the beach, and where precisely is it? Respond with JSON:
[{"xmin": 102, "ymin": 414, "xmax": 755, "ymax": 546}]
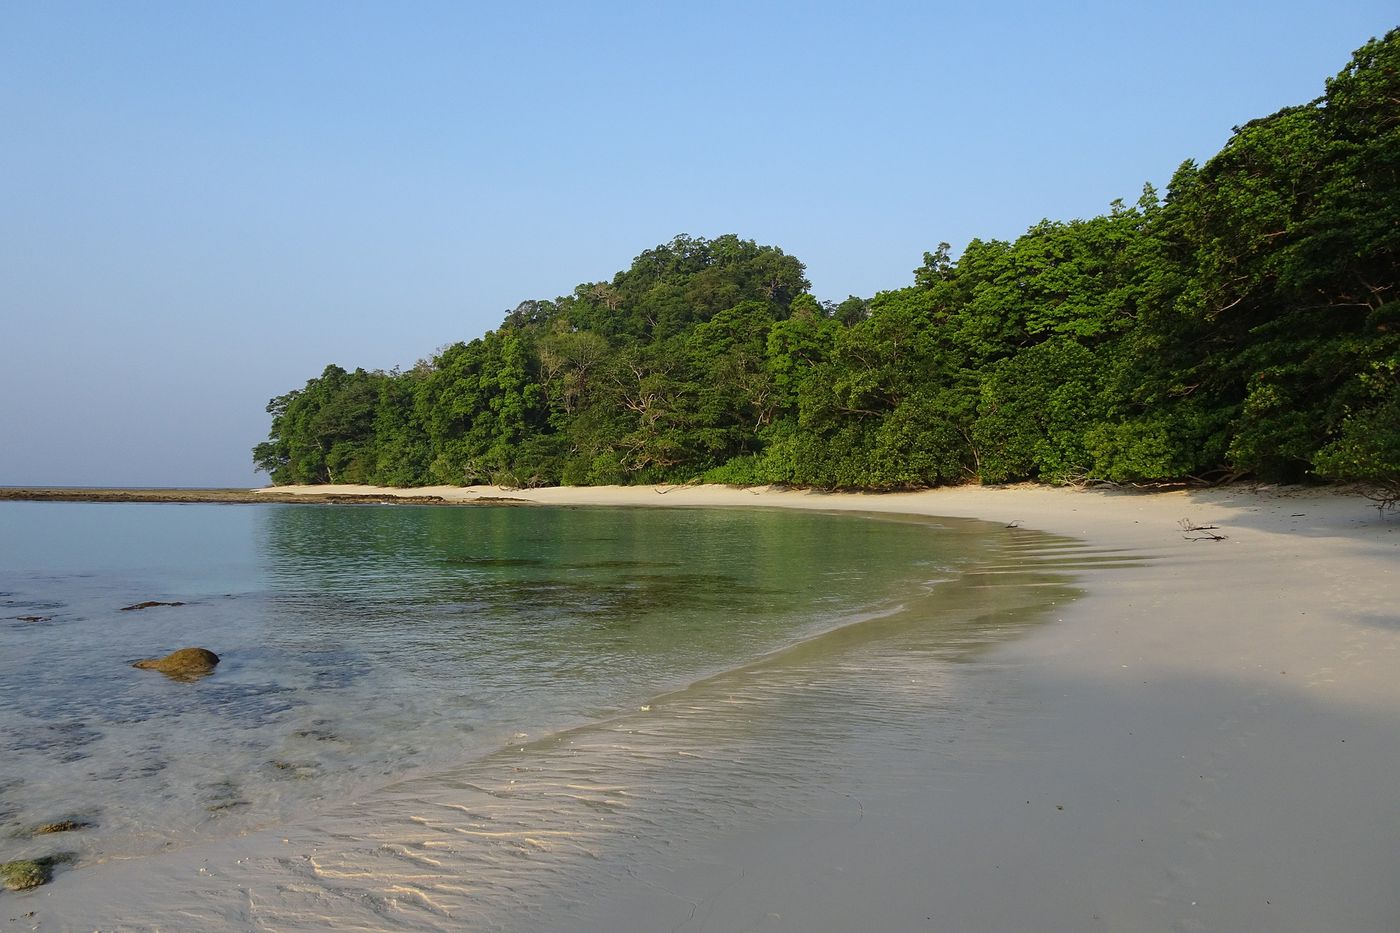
[{"xmin": 253, "ymin": 29, "xmax": 1400, "ymax": 493}]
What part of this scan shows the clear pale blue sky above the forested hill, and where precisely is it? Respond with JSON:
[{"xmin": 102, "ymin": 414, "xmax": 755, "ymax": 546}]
[{"xmin": 0, "ymin": 0, "xmax": 1400, "ymax": 486}]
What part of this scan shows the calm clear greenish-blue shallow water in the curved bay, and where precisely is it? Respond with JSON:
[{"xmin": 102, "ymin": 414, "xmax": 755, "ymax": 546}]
[{"xmin": 0, "ymin": 503, "xmax": 1005, "ymax": 860}]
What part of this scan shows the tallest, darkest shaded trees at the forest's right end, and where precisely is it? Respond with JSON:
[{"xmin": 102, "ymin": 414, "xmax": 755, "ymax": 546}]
[{"xmin": 1120, "ymin": 31, "xmax": 1400, "ymax": 479}]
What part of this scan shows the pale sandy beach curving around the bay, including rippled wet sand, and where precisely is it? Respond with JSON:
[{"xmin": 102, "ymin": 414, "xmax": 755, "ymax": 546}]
[{"xmin": 13, "ymin": 486, "xmax": 1400, "ymax": 933}]
